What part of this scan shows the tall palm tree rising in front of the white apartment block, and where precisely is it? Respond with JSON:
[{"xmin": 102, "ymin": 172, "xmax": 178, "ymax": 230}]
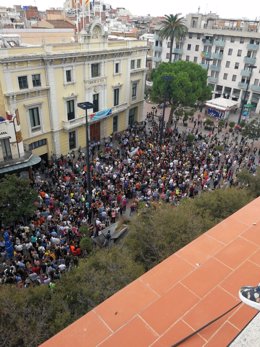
[{"xmin": 159, "ymin": 13, "xmax": 188, "ymax": 63}]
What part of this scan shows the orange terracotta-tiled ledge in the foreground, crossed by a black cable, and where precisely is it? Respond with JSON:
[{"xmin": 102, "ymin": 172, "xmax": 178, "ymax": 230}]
[{"xmin": 41, "ymin": 198, "xmax": 260, "ymax": 347}]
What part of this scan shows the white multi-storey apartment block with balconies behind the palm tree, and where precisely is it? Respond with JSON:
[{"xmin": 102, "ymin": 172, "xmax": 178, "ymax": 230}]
[{"xmin": 153, "ymin": 13, "xmax": 260, "ymax": 113}]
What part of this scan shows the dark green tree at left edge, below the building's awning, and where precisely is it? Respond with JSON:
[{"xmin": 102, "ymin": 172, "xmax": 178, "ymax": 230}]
[{"xmin": 0, "ymin": 175, "xmax": 37, "ymax": 224}]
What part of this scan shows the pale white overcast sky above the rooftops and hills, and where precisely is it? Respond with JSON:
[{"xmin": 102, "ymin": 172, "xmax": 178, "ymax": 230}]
[{"xmin": 0, "ymin": 0, "xmax": 260, "ymax": 20}]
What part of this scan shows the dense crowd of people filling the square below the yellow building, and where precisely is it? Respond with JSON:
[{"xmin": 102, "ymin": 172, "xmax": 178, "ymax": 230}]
[{"xmin": 0, "ymin": 109, "xmax": 259, "ymax": 287}]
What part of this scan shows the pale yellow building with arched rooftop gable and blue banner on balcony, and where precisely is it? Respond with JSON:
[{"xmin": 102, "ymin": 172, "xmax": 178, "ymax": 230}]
[{"xmin": 0, "ymin": 21, "xmax": 147, "ymax": 159}]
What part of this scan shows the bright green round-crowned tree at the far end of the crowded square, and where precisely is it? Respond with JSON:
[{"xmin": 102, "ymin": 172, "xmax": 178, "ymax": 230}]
[{"xmin": 151, "ymin": 60, "xmax": 211, "ymax": 124}]
